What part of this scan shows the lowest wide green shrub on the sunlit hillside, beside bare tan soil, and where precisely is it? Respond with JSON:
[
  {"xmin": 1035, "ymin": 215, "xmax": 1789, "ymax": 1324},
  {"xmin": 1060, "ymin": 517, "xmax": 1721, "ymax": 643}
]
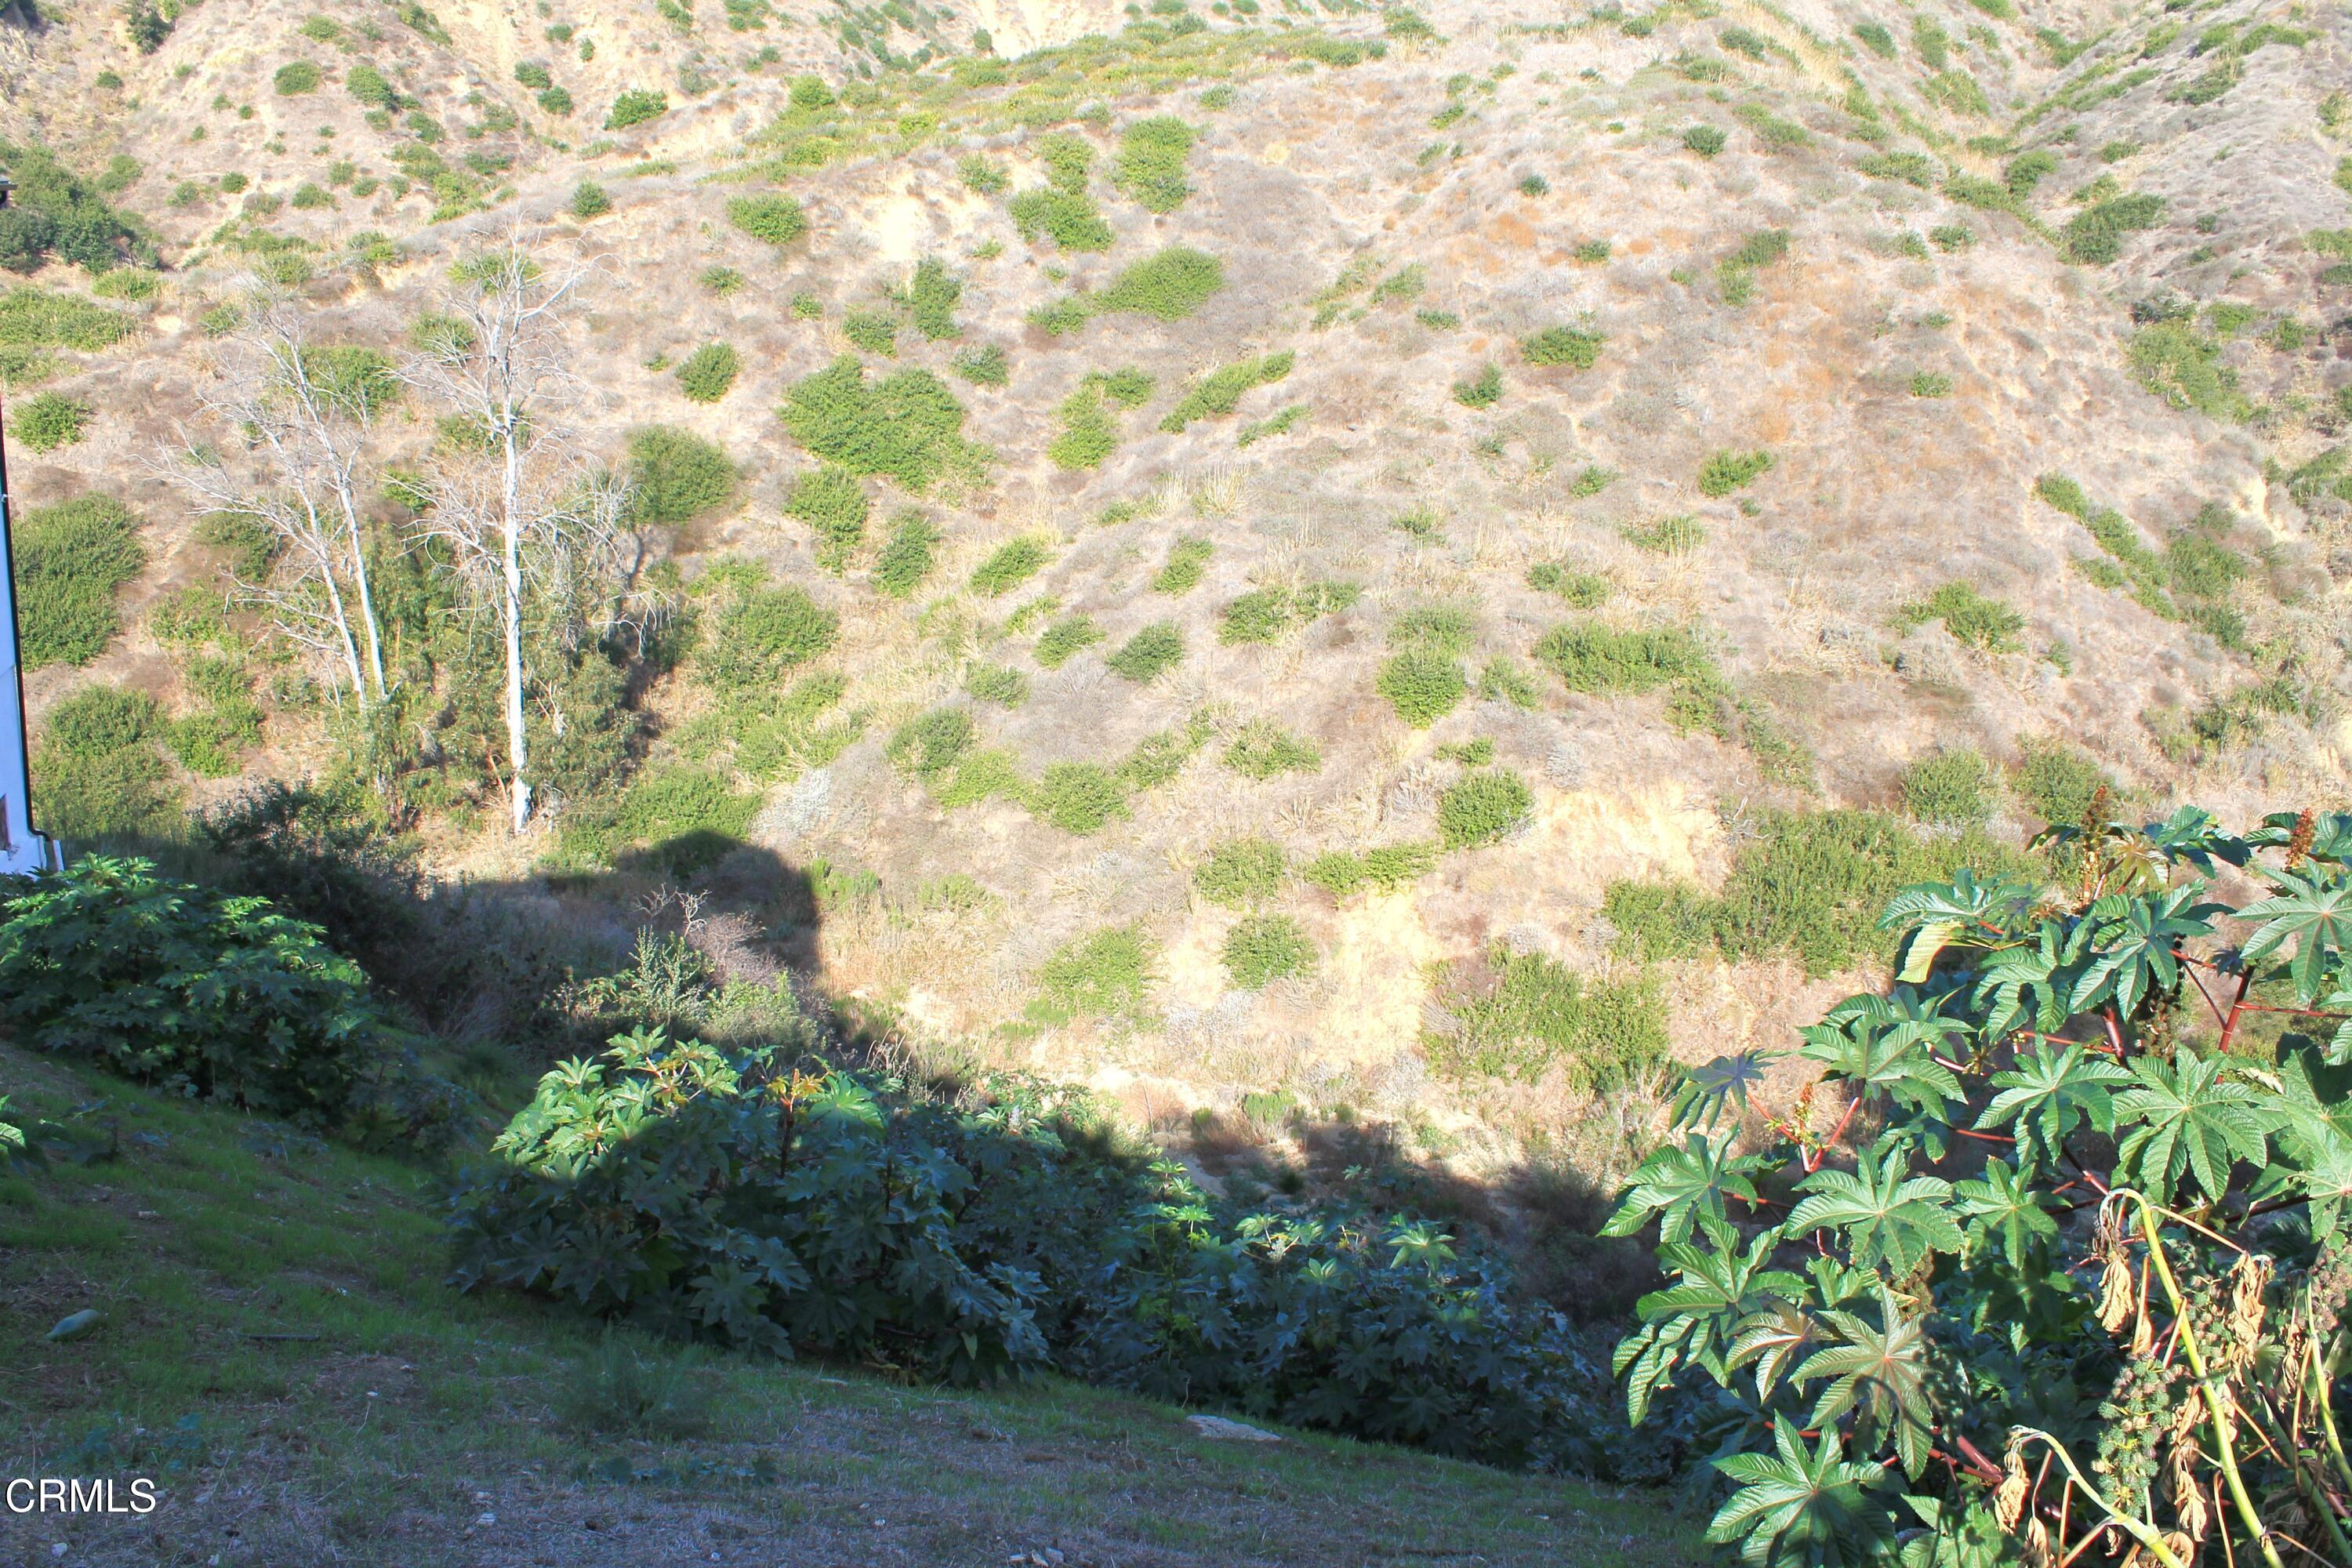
[{"xmin": 1421, "ymin": 947, "xmax": 1670, "ymax": 1093}]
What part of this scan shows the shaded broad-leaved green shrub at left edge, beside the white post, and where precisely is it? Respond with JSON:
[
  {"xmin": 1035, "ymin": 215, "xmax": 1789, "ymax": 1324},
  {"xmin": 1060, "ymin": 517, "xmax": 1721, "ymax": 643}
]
[{"xmin": 0, "ymin": 855, "xmax": 388, "ymax": 1126}]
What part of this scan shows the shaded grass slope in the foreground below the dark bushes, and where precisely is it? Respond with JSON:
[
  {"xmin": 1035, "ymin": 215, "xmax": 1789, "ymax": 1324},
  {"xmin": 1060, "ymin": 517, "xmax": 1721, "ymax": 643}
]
[{"xmin": 0, "ymin": 1044, "xmax": 1703, "ymax": 1568}]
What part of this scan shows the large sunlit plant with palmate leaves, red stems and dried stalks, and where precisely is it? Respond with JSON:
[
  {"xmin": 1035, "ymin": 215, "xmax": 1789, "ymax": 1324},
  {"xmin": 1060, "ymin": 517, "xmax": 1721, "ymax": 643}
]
[{"xmin": 1609, "ymin": 808, "xmax": 2352, "ymax": 1568}]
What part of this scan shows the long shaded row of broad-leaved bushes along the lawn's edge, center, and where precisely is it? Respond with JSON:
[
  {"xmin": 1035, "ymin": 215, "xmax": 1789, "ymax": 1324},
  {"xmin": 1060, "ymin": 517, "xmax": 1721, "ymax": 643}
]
[{"xmin": 452, "ymin": 1029, "xmax": 1637, "ymax": 1465}]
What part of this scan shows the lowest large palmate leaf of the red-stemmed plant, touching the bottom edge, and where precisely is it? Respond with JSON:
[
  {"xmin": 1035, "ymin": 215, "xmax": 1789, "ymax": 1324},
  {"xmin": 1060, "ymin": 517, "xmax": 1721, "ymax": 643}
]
[{"xmin": 1708, "ymin": 1415, "xmax": 1893, "ymax": 1568}]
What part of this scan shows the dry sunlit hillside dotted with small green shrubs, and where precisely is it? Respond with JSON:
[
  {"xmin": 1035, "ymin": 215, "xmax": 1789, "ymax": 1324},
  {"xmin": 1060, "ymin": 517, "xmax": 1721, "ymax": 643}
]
[{"xmin": 0, "ymin": 0, "xmax": 2352, "ymax": 1222}]
